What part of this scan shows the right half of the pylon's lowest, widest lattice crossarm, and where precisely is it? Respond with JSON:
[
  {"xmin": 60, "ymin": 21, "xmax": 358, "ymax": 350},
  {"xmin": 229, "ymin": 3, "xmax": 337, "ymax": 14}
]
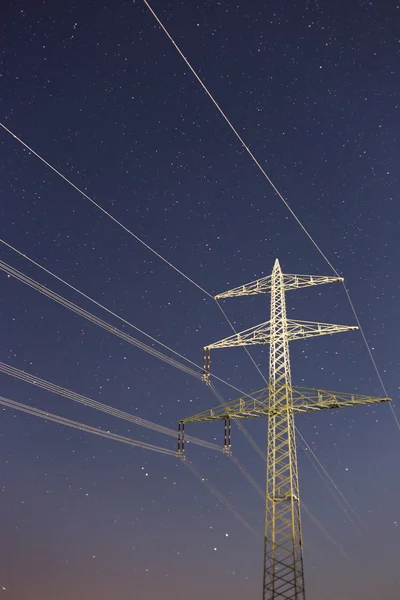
[{"xmin": 292, "ymin": 386, "xmax": 391, "ymax": 413}]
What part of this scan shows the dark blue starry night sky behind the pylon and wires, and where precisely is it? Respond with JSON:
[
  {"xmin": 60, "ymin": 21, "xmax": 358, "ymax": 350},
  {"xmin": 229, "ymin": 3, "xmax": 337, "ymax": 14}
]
[{"xmin": 0, "ymin": 0, "xmax": 400, "ymax": 600}]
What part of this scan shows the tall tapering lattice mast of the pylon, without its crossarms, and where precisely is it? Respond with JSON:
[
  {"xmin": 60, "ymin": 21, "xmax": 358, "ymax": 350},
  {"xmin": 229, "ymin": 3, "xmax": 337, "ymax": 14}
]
[{"xmin": 263, "ymin": 259, "xmax": 304, "ymax": 600}]
